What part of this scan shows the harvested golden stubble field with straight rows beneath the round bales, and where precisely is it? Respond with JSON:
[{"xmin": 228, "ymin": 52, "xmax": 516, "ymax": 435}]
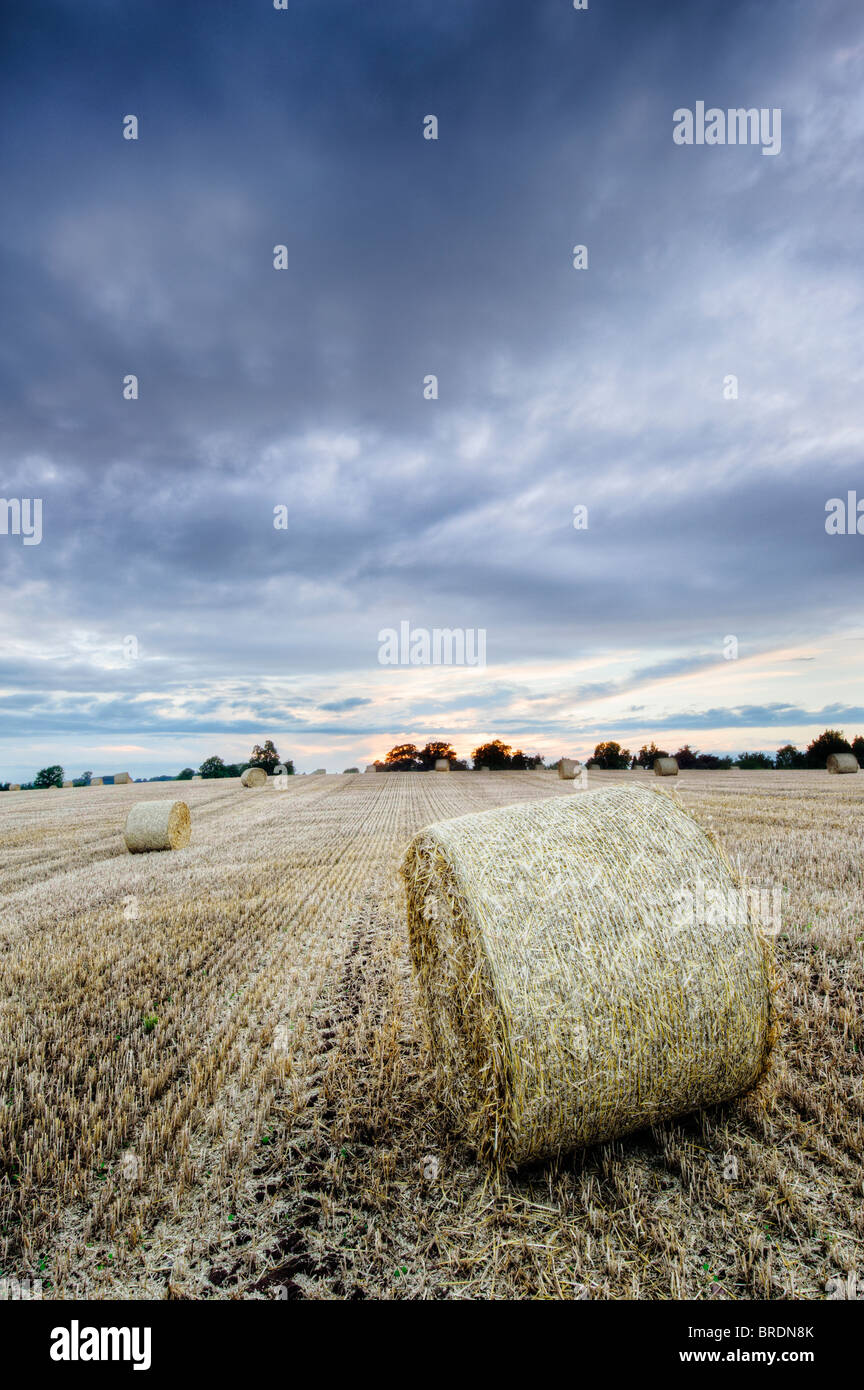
[{"xmin": 0, "ymin": 771, "xmax": 864, "ymax": 1300}]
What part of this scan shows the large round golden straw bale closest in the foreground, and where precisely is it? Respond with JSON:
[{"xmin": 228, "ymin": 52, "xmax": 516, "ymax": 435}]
[{"xmin": 403, "ymin": 784, "xmax": 771, "ymax": 1163}]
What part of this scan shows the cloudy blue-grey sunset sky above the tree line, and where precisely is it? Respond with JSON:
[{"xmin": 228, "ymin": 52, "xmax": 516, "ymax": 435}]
[{"xmin": 0, "ymin": 0, "xmax": 864, "ymax": 781}]
